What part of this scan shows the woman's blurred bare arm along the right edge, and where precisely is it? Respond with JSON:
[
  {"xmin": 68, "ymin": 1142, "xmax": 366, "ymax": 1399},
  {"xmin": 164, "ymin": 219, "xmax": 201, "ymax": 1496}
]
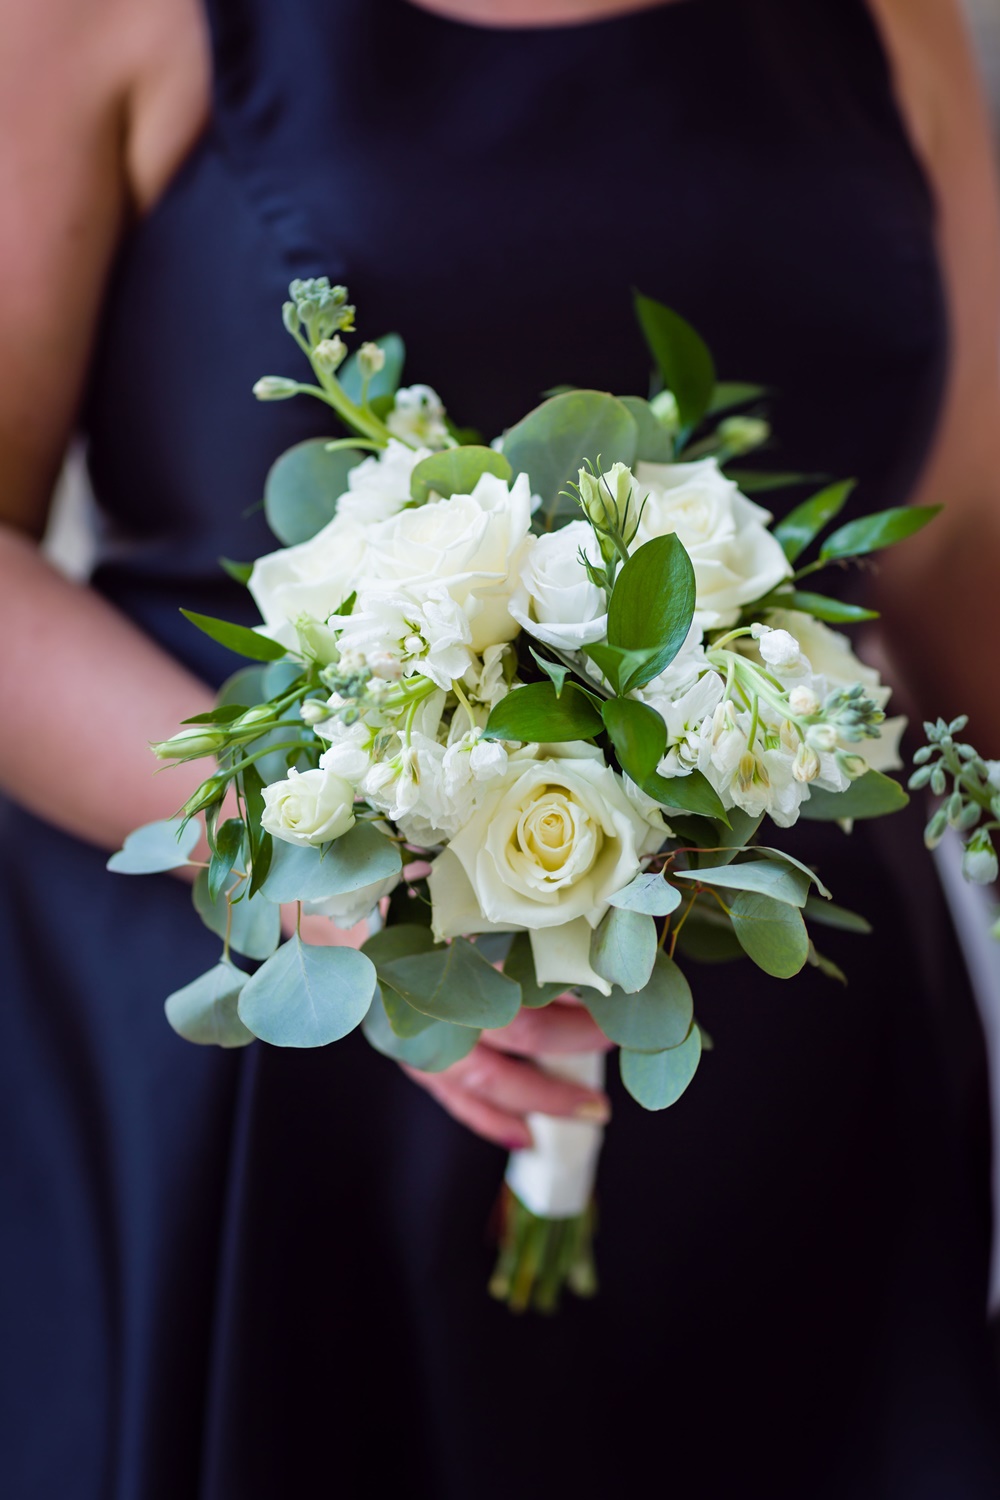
[{"xmin": 871, "ymin": 0, "xmax": 1000, "ymax": 755}]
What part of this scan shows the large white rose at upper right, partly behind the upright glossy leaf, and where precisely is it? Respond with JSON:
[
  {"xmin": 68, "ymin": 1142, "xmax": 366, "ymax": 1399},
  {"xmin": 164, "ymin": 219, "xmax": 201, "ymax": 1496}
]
[{"xmin": 633, "ymin": 459, "xmax": 792, "ymax": 630}]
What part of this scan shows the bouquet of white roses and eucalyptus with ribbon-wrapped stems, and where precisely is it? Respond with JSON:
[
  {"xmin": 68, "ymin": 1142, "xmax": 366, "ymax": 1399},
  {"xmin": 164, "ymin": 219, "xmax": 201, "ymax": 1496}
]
[{"xmin": 111, "ymin": 279, "xmax": 933, "ymax": 1308}]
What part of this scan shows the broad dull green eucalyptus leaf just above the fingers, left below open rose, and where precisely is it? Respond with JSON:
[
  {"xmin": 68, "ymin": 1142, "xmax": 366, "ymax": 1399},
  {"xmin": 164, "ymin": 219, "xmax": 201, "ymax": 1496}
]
[{"xmin": 379, "ymin": 938, "xmax": 520, "ymax": 1028}]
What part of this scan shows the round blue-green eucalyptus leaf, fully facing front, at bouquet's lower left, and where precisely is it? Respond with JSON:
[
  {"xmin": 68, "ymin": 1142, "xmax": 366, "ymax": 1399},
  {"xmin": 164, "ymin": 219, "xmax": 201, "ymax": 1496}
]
[{"xmin": 238, "ymin": 938, "xmax": 375, "ymax": 1047}]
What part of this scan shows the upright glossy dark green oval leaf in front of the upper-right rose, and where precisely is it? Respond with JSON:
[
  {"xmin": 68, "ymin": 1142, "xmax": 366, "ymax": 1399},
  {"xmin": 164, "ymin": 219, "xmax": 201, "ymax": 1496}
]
[{"xmin": 607, "ymin": 533, "xmax": 694, "ymax": 693}]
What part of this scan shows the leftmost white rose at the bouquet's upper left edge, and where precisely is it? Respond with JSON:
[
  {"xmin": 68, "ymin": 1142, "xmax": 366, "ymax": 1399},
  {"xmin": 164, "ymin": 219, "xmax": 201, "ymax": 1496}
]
[{"xmin": 247, "ymin": 516, "xmax": 367, "ymax": 650}]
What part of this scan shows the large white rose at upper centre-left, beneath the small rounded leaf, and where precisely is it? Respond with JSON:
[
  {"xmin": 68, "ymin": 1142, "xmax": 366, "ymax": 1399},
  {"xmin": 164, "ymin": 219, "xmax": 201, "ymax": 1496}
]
[{"xmin": 366, "ymin": 474, "xmax": 531, "ymax": 651}]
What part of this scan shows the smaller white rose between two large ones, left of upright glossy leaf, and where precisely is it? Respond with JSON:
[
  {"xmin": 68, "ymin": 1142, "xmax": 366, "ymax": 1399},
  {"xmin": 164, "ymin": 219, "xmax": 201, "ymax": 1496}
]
[{"xmin": 508, "ymin": 521, "xmax": 607, "ymax": 651}]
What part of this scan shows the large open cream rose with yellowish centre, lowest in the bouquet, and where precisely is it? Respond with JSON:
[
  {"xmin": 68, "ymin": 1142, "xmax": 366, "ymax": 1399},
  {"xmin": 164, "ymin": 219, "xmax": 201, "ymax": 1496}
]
[{"xmin": 430, "ymin": 743, "xmax": 663, "ymax": 995}]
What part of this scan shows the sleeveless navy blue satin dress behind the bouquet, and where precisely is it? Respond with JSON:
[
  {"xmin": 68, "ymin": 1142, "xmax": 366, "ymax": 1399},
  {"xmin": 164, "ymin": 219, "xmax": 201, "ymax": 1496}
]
[{"xmin": 0, "ymin": 0, "xmax": 1000, "ymax": 1500}]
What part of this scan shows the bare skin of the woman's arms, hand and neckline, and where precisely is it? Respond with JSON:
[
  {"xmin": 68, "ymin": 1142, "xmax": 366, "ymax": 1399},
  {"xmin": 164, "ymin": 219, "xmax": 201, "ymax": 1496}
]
[{"xmin": 0, "ymin": 0, "xmax": 1000, "ymax": 1148}]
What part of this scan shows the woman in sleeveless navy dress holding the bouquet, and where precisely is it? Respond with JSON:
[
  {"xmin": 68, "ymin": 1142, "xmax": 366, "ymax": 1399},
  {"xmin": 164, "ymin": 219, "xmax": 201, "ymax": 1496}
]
[{"xmin": 0, "ymin": 0, "xmax": 1000, "ymax": 1500}]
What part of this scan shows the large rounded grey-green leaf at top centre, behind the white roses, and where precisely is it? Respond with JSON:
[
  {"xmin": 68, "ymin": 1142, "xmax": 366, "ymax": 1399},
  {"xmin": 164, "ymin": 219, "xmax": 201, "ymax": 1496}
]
[{"xmin": 504, "ymin": 390, "xmax": 639, "ymax": 509}]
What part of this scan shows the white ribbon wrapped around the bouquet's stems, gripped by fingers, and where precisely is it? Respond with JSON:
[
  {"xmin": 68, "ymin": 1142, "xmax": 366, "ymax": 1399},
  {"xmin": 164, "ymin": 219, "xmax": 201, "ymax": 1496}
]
[{"xmin": 507, "ymin": 1052, "xmax": 604, "ymax": 1218}]
